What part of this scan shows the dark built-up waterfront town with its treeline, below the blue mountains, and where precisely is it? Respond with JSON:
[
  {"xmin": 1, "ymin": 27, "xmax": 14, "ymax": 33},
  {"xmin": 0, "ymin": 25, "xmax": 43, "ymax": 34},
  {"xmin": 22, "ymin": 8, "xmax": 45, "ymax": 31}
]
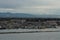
[{"xmin": 0, "ymin": 18, "xmax": 60, "ymax": 29}]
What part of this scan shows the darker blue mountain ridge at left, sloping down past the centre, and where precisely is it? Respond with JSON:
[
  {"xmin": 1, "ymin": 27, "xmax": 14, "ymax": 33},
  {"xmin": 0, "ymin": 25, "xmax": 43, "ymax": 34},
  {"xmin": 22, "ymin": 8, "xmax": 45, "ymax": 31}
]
[{"xmin": 0, "ymin": 13, "xmax": 35, "ymax": 18}]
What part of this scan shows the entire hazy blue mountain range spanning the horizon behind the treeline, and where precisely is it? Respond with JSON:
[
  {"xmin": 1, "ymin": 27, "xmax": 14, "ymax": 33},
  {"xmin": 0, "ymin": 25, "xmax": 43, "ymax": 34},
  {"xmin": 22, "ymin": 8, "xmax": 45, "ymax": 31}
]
[{"xmin": 0, "ymin": 12, "xmax": 60, "ymax": 18}]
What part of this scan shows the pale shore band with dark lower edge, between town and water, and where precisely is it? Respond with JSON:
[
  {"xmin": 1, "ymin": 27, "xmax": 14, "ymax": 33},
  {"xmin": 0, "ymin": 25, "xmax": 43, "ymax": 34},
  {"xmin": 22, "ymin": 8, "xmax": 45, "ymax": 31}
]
[{"xmin": 0, "ymin": 29, "xmax": 60, "ymax": 34}]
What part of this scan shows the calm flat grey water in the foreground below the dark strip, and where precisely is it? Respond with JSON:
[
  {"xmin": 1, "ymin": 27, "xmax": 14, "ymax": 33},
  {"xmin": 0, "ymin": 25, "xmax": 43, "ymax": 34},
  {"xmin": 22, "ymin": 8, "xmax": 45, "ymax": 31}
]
[{"xmin": 0, "ymin": 32, "xmax": 60, "ymax": 40}]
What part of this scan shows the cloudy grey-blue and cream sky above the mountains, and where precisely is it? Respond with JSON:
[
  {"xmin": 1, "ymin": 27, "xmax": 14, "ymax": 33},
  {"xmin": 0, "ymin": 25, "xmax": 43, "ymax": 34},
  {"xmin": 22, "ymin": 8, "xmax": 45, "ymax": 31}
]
[{"xmin": 0, "ymin": 0, "xmax": 60, "ymax": 15}]
